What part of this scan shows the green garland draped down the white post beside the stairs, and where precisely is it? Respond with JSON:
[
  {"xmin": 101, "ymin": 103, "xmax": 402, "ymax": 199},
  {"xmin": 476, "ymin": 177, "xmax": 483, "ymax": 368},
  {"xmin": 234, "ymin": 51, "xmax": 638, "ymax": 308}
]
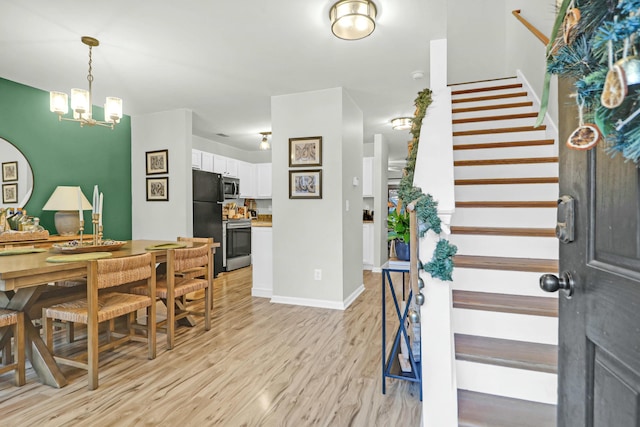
[{"xmin": 398, "ymin": 89, "xmax": 458, "ymax": 281}]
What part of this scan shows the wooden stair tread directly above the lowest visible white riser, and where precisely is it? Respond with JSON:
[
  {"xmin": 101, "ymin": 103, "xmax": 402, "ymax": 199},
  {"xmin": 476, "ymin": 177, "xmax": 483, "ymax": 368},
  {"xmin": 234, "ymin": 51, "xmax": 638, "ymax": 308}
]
[{"xmin": 455, "ymin": 334, "xmax": 558, "ymax": 374}]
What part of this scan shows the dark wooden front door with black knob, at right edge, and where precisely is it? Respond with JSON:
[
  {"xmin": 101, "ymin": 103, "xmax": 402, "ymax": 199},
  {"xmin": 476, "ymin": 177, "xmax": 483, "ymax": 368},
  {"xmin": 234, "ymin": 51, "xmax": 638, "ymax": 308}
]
[{"xmin": 558, "ymin": 77, "xmax": 640, "ymax": 427}]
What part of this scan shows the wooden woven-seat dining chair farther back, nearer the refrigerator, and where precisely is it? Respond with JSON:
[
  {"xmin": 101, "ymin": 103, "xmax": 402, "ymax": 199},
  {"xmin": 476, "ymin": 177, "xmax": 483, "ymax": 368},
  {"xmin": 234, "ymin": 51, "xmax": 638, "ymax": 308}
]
[{"xmin": 130, "ymin": 238, "xmax": 213, "ymax": 350}]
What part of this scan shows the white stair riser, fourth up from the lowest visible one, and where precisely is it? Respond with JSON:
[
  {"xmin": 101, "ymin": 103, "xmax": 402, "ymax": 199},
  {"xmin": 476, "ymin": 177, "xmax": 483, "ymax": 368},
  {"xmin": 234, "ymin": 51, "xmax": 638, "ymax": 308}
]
[{"xmin": 449, "ymin": 234, "xmax": 558, "ymax": 259}]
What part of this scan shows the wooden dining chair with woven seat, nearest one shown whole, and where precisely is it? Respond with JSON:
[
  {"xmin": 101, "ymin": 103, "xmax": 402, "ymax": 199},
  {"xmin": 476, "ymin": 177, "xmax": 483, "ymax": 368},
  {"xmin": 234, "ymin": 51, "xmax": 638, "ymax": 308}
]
[{"xmin": 42, "ymin": 253, "xmax": 156, "ymax": 390}]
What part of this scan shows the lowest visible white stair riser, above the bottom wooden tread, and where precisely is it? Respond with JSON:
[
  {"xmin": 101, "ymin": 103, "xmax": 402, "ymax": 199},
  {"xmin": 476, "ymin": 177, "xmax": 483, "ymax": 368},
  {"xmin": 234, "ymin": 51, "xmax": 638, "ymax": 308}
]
[{"xmin": 456, "ymin": 360, "xmax": 558, "ymax": 404}]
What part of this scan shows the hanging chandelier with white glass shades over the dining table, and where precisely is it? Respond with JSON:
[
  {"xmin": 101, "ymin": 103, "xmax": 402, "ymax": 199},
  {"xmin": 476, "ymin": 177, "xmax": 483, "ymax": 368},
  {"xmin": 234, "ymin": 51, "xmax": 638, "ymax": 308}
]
[{"xmin": 49, "ymin": 36, "xmax": 122, "ymax": 129}]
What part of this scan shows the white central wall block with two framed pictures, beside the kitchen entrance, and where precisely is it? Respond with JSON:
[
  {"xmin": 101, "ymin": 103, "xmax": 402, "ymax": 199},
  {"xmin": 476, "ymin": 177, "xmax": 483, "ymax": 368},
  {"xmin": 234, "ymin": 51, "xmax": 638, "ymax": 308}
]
[{"xmin": 271, "ymin": 88, "xmax": 363, "ymax": 308}]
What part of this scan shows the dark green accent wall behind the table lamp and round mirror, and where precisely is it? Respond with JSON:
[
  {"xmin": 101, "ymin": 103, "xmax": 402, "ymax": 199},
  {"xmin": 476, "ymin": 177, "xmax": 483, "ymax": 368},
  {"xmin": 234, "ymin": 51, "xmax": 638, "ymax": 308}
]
[{"xmin": 0, "ymin": 78, "xmax": 131, "ymax": 240}]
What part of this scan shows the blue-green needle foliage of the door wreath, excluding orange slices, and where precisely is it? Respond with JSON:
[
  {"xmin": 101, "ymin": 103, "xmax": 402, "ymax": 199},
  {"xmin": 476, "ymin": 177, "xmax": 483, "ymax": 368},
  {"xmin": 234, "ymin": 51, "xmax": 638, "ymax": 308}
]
[{"xmin": 547, "ymin": 0, "xmax": 640, "ymax": 164}]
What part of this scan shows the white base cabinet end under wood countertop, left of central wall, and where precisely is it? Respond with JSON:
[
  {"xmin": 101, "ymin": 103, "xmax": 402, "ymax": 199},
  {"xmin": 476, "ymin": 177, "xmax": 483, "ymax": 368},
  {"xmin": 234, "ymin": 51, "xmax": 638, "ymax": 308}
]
[{"xmin": 251, "ymin": 227, "xmax": 273, "ymax": 298}]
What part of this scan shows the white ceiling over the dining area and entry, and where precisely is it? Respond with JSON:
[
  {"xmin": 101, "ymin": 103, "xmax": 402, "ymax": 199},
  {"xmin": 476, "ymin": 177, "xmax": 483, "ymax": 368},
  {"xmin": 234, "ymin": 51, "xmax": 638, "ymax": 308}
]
[{"xmin": 0, "ymin": 0, "xmax": 445, "ymax": 159}]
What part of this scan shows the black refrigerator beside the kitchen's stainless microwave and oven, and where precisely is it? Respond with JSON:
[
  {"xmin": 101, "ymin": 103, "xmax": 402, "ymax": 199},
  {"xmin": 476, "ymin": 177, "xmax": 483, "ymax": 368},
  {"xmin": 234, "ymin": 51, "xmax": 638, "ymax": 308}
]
[{"xmin": 193, "ymin": 170, "xmax": 224, "ymax": 277}]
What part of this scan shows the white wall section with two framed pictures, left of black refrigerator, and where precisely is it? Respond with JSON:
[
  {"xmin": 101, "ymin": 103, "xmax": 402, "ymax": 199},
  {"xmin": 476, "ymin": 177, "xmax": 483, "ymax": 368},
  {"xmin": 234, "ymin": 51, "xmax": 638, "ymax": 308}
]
[{"xmin": 131, "ymin": 109, "xmax": 193, "ymax": 240}]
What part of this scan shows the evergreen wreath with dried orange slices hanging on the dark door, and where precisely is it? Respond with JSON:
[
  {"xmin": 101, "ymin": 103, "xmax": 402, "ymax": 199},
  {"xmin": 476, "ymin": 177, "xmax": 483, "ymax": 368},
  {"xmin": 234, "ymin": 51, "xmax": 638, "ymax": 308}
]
[{"xmin": 539, "ymin": 0, "xmax": 640, "ymax": 163}]
